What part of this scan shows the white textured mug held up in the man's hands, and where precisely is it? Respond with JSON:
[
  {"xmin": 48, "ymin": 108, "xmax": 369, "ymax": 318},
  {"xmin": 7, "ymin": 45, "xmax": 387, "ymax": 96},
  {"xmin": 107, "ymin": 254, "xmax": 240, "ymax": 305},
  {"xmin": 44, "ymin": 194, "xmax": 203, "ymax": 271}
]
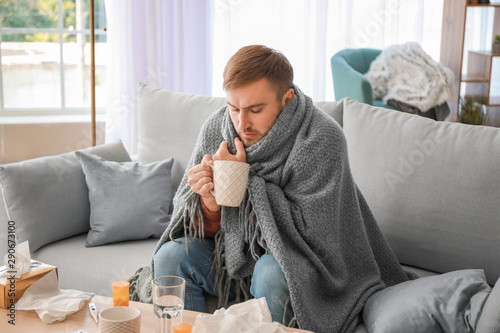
[{"xmin": 208, "ymin": 160, "xmax": 250, "ymax": 207}]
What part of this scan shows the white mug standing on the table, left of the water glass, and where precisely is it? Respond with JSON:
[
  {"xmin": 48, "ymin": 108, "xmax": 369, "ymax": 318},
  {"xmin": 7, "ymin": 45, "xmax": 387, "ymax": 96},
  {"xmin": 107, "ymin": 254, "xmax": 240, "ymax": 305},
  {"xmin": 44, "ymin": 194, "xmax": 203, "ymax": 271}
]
[{"xmin": 99, "ymin": 306, "xmax": 141, "ymax": 333}]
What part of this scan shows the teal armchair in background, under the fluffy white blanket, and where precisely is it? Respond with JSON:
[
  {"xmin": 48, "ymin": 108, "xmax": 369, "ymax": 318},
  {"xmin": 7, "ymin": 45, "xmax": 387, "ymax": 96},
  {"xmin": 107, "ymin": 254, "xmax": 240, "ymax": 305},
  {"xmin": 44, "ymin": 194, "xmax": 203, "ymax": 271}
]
[{"xmin": 331, "ymin": 49, "xmax": 395, "ymax": 109}]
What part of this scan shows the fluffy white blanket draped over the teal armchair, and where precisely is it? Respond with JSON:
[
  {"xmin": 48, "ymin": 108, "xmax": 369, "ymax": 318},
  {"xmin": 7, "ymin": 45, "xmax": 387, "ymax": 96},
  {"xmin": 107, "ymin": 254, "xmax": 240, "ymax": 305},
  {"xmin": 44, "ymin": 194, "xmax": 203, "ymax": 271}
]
[{"xmin": 365, "ymin": 42, "xmax": 455, "ymax": 112}]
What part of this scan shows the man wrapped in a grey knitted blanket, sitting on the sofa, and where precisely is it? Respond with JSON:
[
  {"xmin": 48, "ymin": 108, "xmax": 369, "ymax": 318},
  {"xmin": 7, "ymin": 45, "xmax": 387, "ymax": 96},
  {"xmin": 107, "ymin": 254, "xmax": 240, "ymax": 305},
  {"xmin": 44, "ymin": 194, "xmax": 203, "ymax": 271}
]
[{"xmin": 134, "ymin": 45, "xmax": 407, "ymax": 333}]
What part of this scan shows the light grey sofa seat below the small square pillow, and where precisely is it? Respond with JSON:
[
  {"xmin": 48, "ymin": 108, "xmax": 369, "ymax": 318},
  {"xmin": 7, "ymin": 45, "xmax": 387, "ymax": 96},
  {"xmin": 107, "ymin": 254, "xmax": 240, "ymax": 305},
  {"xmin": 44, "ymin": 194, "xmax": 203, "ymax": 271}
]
[{"xmin": 31, "ymin": 233, "xmax": 158, "ymax": 296}]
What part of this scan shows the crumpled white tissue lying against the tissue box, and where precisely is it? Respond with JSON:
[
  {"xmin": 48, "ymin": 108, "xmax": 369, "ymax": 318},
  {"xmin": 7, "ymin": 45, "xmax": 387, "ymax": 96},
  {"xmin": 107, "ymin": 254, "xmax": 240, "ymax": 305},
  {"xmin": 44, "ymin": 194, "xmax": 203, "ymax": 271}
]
[{"xmin": 16, "ymin": 270, "xmax": 94, "ymax": 324}]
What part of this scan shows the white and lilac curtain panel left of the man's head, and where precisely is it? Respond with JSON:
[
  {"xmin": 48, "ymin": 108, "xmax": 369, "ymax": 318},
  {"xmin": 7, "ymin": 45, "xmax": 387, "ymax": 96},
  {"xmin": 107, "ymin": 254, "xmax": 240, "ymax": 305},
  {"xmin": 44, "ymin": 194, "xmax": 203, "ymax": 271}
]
[{"xmin": 105, "ymin": 0, "xmax": 212, "ymax": 154}]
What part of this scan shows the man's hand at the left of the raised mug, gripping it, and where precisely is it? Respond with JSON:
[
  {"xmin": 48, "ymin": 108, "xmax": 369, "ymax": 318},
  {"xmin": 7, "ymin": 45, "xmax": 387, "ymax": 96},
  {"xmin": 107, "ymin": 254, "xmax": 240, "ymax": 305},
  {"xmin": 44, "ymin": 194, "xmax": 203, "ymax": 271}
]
[{"xmin": 187, "ymin": 155, "xmax": 220, "ymax": 212}]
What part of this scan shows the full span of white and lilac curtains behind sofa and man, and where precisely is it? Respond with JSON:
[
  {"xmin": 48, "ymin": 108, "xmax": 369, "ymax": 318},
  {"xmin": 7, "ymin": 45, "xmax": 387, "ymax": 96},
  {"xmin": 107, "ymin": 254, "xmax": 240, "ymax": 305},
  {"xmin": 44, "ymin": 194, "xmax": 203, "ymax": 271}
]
[{"xmin": 105, "ymin": 0, "xmax": 443, "ymax": 154}]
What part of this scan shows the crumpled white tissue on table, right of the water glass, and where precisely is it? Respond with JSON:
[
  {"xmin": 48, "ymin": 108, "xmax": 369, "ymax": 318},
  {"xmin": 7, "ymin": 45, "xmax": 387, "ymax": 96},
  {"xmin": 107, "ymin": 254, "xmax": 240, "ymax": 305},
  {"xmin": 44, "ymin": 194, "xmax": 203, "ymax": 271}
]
[{"xmin": 192, "ymin": 297, "xmax": 296, "ymax": 333}]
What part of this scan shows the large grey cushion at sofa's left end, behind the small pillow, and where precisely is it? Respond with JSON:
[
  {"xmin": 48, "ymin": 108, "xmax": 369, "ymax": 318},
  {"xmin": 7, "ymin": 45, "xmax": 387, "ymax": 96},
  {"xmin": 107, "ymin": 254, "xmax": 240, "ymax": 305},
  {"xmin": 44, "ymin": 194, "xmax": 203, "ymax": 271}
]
[{"xmin": 0, "ymin": 142, "xmax": 130, "ymax": 251}]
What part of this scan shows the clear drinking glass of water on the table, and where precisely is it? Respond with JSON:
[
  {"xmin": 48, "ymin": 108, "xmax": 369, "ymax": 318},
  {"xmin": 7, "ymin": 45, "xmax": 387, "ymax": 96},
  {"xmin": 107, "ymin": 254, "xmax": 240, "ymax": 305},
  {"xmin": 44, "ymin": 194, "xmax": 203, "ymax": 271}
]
[{"xmin": 151, "ymin": 275, "xmax": 186, "ymax": 333}]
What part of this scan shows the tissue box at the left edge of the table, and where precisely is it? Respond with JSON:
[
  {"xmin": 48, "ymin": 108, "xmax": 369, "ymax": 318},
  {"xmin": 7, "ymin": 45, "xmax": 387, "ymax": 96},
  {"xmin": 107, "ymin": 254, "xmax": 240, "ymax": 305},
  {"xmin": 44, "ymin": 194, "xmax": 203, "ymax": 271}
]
[{"xmin": 0, "ymin": 263, "xmax": 57, "ymax": 309}]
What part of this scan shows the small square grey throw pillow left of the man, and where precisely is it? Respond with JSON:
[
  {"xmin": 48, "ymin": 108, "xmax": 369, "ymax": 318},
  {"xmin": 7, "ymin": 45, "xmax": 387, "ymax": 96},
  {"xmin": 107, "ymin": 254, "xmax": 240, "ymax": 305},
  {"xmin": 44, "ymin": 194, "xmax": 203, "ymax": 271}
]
[{"xmin": 76, "ymin": 152, "xmax": 174, "ymax": 247}]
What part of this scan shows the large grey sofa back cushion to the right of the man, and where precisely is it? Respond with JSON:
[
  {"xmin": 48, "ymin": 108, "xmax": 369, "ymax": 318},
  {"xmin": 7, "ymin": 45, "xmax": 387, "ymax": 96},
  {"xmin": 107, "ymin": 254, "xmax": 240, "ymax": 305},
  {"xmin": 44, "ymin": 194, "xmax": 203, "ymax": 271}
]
[{"xmin": 343, "ymin": 99, "xmax": 500, "ymax": 284}]
